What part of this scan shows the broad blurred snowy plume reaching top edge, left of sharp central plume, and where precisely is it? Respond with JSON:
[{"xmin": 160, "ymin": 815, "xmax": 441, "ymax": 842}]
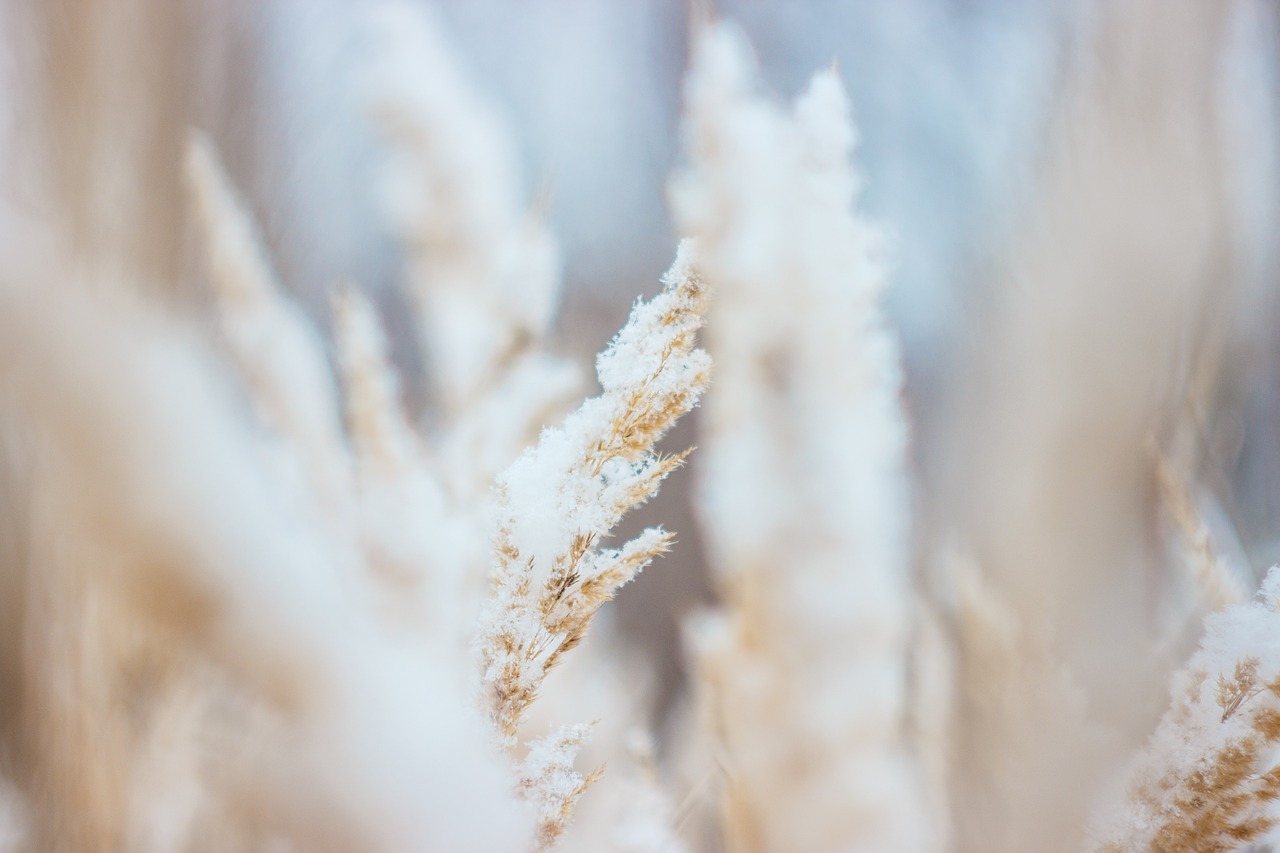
[{"xmin": 366, "ymin": 1, "xmax": 580, "ymax": 479}]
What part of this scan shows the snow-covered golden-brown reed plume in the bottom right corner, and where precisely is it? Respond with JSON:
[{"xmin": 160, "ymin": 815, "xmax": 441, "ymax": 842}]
[{"xmin": 1091, "ymin": 569, "xmax": 1280, "ymax": 853}]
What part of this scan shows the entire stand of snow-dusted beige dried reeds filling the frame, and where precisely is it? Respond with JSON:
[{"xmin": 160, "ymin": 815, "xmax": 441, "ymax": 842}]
[{"xmin": 0, "ymin": 0, "xmax": 1280, "ymax": 853}]
